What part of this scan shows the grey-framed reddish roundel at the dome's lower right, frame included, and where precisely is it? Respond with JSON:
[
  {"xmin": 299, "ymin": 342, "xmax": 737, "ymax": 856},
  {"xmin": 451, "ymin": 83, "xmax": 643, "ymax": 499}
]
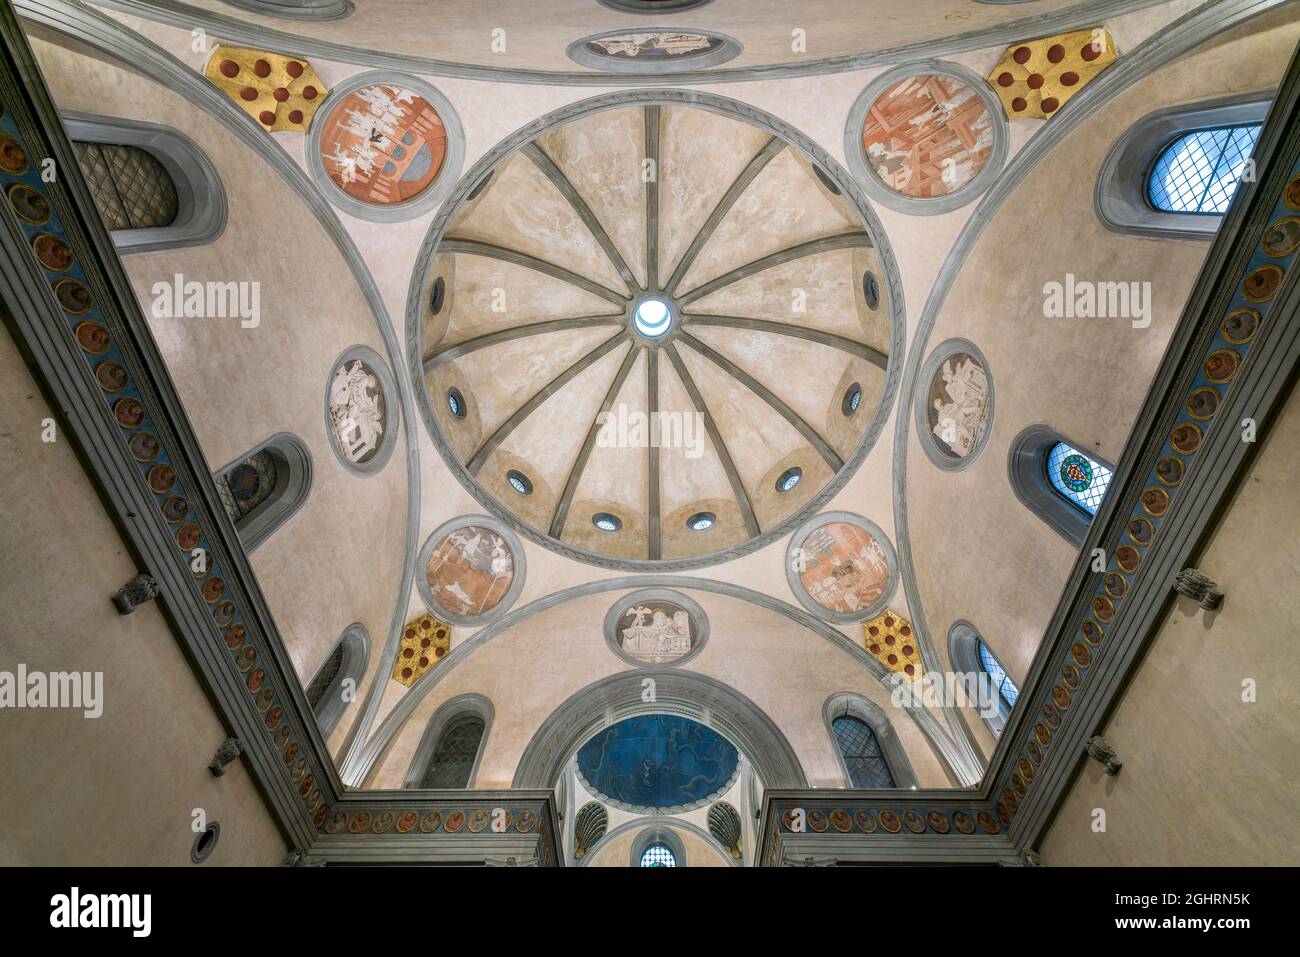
[{"xmin": 787, "ymin": 512, "xmax": 898, "ymax": 622}]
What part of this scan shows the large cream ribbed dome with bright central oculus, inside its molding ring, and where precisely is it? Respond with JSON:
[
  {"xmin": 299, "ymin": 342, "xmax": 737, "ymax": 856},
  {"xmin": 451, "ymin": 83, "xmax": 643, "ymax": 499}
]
[{"xmin": 413, "ymin": 99, "xmax": 896, "ymax": 567}]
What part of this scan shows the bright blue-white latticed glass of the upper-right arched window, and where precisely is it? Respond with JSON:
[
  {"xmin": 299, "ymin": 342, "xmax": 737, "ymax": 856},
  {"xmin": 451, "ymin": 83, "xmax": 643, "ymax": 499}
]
[{"xmin": 1147, "ymin": 124, "xmax": 1261, "ymax": 216}]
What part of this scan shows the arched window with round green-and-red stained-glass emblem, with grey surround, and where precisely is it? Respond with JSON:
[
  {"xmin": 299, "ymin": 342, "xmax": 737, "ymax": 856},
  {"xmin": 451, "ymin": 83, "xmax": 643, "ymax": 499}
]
[{"xmin": 1008, "ymin": 425, "xmax": 1114, "ymax": 547}]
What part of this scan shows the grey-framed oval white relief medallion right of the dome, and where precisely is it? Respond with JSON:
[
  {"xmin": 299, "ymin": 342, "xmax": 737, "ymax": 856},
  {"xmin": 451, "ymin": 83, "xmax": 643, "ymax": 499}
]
[{"xmin": 917, "ymin": 339, "xmax": 993, "ymax": 469}]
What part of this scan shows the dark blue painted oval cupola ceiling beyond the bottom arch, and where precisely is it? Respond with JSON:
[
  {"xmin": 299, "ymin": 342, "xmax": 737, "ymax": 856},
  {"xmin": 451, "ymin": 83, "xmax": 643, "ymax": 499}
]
[{"xmin": 577, "ymin": 714, "xmax": 740, "ymax": 814}]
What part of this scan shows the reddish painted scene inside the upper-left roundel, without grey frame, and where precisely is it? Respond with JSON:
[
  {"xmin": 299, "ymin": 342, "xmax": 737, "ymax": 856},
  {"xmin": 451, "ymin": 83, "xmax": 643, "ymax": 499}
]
[{"xmin": 321, "ymin": 83, "xmax": 447, "ymax": 207}]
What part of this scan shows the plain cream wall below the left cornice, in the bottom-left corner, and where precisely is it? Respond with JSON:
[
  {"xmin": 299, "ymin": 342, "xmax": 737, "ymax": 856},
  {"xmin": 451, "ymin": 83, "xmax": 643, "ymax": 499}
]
[{"xmin": 0, "ymin": 329, "xmax": 287, "ymax": 867}]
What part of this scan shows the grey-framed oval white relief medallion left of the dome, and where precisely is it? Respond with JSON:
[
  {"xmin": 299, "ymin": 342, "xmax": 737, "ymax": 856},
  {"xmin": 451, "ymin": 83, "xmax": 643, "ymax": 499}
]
[{"xmin": 325, "ymin": 347, "xmax": 397, "ymax": 472}]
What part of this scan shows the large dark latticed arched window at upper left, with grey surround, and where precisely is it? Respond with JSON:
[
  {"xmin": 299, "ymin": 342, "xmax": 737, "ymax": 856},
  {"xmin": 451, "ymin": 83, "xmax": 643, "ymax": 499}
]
[{"xmin": 62, "ymin": 113, "xmax": 226, "ymax": 255}]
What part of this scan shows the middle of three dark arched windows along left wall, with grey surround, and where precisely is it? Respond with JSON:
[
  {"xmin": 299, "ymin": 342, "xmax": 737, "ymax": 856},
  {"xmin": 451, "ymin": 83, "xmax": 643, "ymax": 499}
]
[{"xmin": 213, "ymin": 432, "xmax": 312, "ymax": 551}]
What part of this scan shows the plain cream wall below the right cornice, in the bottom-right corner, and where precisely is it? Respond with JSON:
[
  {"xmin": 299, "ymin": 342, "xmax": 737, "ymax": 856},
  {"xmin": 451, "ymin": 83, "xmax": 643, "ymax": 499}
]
[{"xmin": 1040, "ymin": 377, "xmax": 1300, "ymax": 867}]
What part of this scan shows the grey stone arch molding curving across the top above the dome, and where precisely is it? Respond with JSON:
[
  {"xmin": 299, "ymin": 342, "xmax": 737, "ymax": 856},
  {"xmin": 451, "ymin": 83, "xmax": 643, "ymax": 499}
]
[{"xmin": 65, "ymin": 0, "xmax": 1175, "ymax": 87}]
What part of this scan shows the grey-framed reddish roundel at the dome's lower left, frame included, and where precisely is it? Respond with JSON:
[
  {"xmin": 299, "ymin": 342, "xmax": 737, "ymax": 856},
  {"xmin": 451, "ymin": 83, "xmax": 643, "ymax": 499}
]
[{"xmin": 416, "ymin": 518, "xmax": 524, "ymax": 624}]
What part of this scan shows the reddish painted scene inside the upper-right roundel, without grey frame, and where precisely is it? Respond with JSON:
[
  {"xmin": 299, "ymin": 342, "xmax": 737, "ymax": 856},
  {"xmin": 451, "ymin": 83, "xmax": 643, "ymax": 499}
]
[{"xmin": 862, "ymin": 73, "xmax": 993, "ymax": 199}]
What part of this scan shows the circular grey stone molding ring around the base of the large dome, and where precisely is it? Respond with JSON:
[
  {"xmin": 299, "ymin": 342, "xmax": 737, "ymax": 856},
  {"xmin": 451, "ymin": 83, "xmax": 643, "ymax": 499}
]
[{"xmin": 407, "ymin": 90, "xmax": 906, "ymax": 572}]
